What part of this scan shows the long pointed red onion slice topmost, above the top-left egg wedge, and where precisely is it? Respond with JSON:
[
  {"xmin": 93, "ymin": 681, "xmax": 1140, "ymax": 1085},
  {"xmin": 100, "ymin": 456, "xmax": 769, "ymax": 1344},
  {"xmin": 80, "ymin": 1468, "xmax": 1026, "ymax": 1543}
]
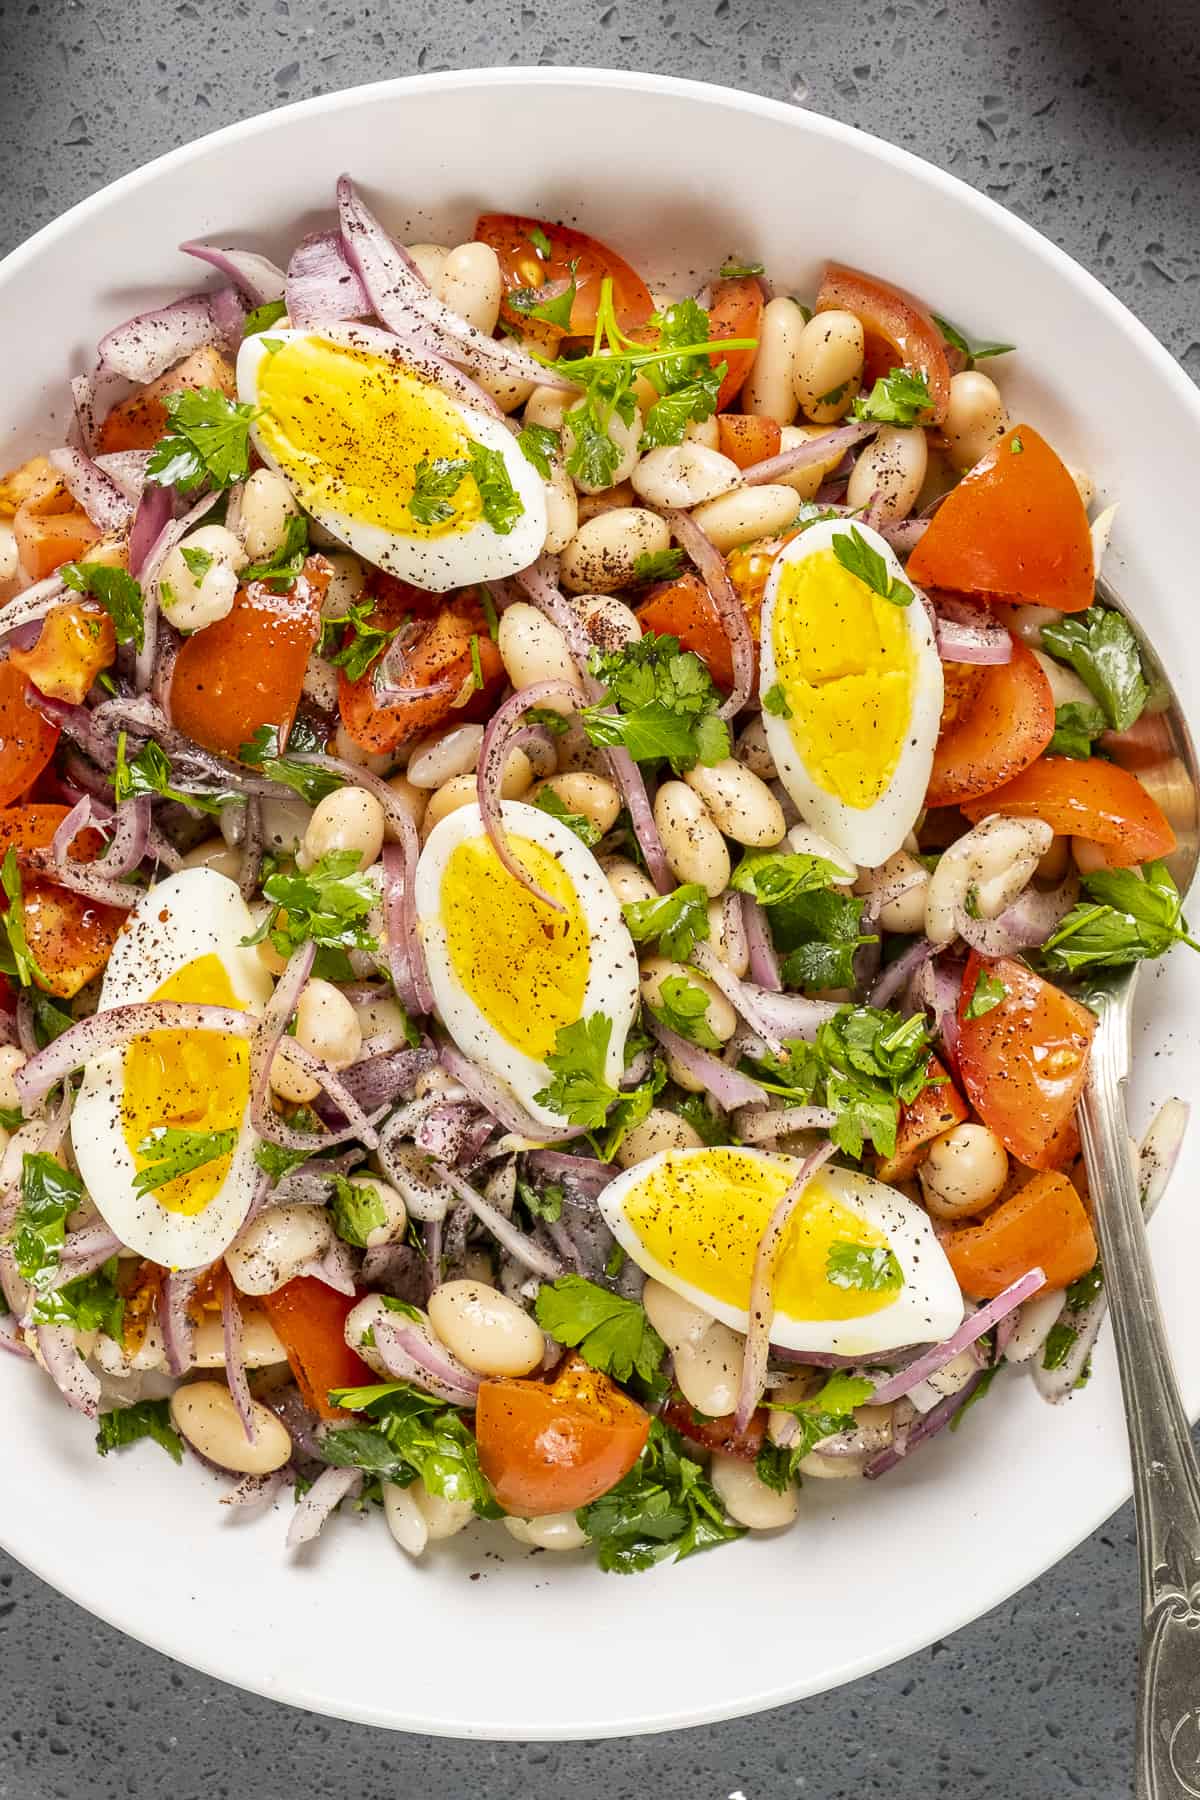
[{"xmin": 338, "ymin": 175, "xmax": 572, "ymax": 389}]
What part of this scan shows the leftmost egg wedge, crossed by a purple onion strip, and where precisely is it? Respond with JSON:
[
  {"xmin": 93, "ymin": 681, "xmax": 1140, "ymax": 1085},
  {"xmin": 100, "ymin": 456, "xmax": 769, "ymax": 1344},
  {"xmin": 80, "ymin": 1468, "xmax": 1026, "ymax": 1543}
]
[{"xmin": 70, "ymin": 869, "xmax": 272, "ymax": 1269}]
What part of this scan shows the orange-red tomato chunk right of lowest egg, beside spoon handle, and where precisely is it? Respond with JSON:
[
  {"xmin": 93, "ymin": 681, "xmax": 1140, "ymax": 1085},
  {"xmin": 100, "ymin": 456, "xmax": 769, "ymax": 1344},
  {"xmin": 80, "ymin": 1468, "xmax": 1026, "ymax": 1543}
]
[{"xmin": 939, "ymin": 1168, "xmax": 1097, "ymax": 1300}]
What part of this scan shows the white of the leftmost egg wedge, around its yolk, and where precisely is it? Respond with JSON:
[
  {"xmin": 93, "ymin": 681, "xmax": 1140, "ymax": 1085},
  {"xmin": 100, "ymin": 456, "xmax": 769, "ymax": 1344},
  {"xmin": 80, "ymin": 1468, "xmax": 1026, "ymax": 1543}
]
[{"xmin": 70, "ymin": 869, "xmax": 273, "ymax": 1269}]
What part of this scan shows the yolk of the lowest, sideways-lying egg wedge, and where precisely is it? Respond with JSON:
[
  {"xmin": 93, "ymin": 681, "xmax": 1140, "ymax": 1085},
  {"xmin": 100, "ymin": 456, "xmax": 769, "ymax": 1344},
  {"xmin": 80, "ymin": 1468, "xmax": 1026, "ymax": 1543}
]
[{"xmin": 624, "ymin": 1148, "xmax": 896, "ymax": 1319}]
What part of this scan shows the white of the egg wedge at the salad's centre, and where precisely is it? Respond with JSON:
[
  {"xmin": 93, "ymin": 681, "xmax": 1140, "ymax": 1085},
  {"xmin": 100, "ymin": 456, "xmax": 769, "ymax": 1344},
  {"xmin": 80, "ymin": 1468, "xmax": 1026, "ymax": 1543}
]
[{"xmin": 416, "ymin": 799, "xmax": 639, "ymax": 1127}]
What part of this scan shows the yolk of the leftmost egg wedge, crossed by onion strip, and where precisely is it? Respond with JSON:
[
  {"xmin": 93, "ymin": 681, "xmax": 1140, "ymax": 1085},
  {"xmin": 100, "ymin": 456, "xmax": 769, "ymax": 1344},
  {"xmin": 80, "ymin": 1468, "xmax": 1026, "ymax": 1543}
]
[{"xmin": 121, "ymin": 954, "xmax": 250, "ymax": 1217}]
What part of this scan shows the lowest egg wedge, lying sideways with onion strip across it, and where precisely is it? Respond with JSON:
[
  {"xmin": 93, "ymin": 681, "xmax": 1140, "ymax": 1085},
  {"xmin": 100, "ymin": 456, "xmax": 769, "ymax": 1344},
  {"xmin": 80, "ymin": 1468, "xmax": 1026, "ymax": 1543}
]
[{"xmin": 599, "ymin": 1148, "xmax": 963, "ymax": 1357}]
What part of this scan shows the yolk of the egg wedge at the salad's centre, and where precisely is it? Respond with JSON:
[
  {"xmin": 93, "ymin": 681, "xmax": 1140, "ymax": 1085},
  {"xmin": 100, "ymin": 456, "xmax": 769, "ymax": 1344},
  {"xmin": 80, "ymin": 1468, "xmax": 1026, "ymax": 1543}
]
[{"xmin": 441, "ymin": 833, "xmax": 590, "ymax": 1062}]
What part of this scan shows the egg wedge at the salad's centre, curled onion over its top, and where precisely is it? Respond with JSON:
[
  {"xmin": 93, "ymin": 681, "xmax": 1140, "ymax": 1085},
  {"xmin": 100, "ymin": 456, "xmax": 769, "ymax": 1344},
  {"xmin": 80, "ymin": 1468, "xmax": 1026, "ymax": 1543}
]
[{"xmin": 416, "ymin": 801, "xmax": 637, "ymax": 1127}]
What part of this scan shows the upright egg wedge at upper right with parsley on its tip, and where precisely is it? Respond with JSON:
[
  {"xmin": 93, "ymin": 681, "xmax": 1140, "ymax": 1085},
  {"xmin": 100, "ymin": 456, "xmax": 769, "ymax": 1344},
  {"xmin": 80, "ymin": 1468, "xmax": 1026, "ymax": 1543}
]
[{"xmin": 761, "ymin": 518, "xmax": 943, "ymax": 868}]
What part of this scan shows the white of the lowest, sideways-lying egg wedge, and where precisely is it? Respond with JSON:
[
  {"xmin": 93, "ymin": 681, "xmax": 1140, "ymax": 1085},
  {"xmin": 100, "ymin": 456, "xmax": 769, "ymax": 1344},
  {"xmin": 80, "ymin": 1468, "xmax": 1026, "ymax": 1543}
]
[{"xmin": 599, "ymin": 1147, "xmax": 963, "ymax": 1357}]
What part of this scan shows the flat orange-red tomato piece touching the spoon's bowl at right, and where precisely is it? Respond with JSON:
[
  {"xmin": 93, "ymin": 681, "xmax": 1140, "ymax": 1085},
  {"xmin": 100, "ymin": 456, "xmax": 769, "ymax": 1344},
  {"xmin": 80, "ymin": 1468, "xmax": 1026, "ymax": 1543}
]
[{"xmin": 963, "ymin": 756, "xmax": 1175, "ymax": 869}]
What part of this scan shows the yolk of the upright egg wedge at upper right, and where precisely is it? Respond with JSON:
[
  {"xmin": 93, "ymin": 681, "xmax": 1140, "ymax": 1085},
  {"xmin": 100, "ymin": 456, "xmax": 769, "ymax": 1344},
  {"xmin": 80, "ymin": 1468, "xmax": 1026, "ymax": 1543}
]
[{"xmin": 772, "ymin": 549, "xmax": 916, "ymax": 810}]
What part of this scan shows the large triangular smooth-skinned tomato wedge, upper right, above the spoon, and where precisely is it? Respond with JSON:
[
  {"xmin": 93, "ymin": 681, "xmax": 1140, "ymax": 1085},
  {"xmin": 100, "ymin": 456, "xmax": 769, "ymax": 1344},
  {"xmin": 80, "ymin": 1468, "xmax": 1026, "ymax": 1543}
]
[{"xmin": 909, "ymin": 425, "xmax": 1096, "ymax": 612}]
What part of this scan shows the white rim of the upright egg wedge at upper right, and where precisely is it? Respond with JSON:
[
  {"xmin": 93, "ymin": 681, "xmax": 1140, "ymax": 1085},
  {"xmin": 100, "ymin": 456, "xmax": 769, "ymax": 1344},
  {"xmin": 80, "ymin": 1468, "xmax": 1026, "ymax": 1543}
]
[{"xmin": 759, "ymin": 518, "xmax": 945, "ymax": 869}]
